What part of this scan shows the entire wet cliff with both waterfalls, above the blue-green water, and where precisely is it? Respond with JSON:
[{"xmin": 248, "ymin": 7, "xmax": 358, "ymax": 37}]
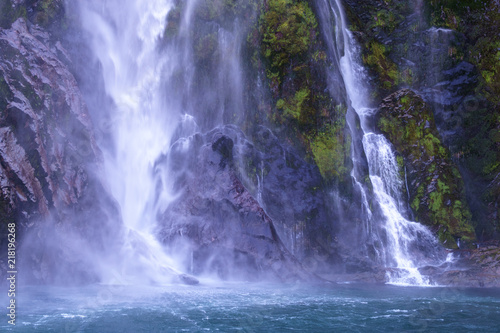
[{"xmin": 0, "ymin": 0, "xmax": 500, "ymax": 286}]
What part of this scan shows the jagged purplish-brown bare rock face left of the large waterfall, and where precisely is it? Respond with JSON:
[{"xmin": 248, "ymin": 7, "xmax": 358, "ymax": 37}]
[{"xmin": 0, "ymin": 18, "xmax": 119, "ymax": 282}]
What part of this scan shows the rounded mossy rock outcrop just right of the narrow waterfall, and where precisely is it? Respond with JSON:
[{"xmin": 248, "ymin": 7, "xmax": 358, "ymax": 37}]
[{"xmin": 378, "ymin": 89, "xmax": 475, "ymax": 248}]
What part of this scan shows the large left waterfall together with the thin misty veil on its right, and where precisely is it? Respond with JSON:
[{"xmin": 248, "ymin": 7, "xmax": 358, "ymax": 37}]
[{"xmin": 80, "ymin": 0, "xmax": 254, "ymax": 283}]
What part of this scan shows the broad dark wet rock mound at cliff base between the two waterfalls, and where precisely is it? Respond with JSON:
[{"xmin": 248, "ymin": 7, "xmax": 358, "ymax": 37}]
[{"xmin": 155, "ymin": 125, "xmax": 336, "ymax": 281}]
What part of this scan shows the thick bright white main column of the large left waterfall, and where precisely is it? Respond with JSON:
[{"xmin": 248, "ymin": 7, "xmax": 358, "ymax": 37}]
[{"xmin": 80, "ymin": 0, "xmax": 185, "ymax": 283}]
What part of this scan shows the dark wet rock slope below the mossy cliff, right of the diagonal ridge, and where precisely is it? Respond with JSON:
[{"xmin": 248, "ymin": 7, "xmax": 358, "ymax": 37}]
[{"xmin": 237, "ymin": 126, "xmax": 335, "ymax": 260}]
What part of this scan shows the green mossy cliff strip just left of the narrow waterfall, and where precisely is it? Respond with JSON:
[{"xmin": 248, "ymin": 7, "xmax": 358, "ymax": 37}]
[{"xmin": 255, "ymin": 0, "xmax": 350, "ymax": 182}]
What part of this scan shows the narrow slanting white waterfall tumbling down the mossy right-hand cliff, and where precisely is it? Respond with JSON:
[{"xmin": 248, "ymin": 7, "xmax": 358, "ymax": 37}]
[{"xmin": 329, "ymin": 0, "xmax": 448, "ymax": 285}]
